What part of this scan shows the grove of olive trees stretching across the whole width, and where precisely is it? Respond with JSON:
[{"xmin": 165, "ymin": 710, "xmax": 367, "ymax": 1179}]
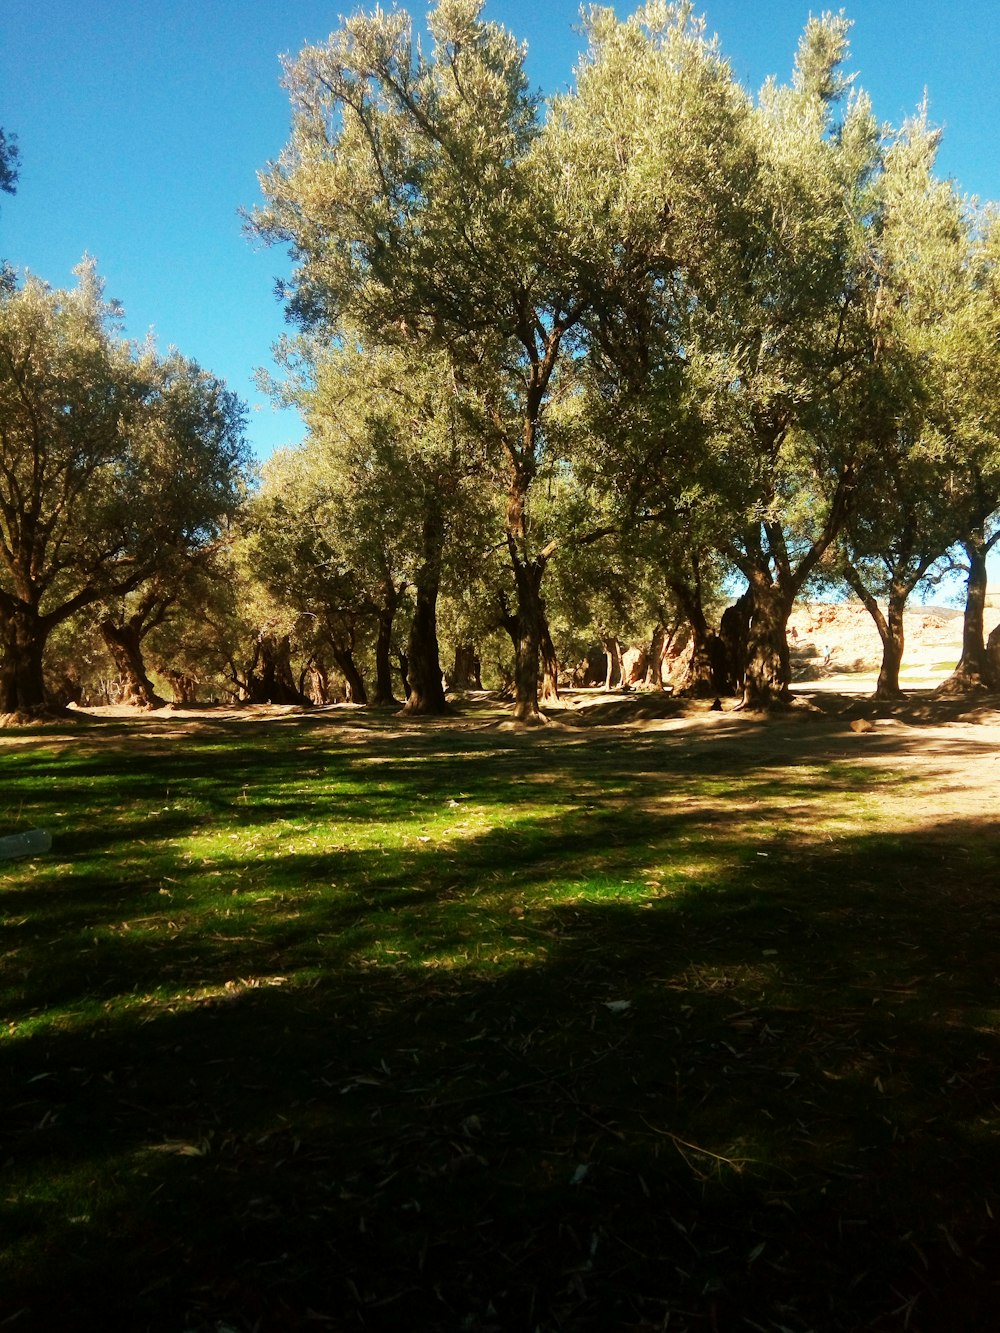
[{"xmin": 0, "ymin": 0, "xmax": 1000, "ymax": 722}]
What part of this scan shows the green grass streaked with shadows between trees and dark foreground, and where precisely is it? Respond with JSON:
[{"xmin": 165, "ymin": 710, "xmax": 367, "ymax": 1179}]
[{"xmin": 4, "ymin": 725, "xmax": 922, "ymax": 1017}]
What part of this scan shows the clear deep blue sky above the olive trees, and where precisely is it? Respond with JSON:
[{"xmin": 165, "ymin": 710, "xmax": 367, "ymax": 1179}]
[{"xmin": 0, "ymin": 0, "xmax": 1000, "ymax": 456}]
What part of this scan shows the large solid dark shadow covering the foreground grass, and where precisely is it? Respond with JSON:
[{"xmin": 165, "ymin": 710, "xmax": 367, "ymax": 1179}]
[{"xmin": 0, "ymin": 789, "xmax": 1000, "ymax": 1333}]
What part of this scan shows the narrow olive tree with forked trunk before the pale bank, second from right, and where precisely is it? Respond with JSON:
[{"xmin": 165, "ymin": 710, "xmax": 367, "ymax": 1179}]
[{"xmin": 836, "ymin": 111, "xmax": 969, "ymax": 698}]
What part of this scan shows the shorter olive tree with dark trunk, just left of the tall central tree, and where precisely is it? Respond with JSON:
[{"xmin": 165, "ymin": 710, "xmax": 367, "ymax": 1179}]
[{"xmin": 284, "ymin": 341, "xmax": 496, "ymax": 713}]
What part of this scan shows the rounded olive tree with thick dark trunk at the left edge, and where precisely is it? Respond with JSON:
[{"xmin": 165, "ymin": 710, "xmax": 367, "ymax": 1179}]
[{"xmin": 0, "ymin": 263, "xmax": 247, "ymax": 713}]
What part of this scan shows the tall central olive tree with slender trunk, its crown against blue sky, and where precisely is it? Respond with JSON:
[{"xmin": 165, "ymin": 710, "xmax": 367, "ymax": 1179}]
[{"xmin": 253, "ymin": 0, "xmax": 677, "ymax": 721}]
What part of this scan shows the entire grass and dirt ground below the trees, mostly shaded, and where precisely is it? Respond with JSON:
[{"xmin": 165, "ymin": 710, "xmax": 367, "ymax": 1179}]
[{"xmin": 0, "ymin": 696, "xmax": 1000, "ymax": 1333}]
